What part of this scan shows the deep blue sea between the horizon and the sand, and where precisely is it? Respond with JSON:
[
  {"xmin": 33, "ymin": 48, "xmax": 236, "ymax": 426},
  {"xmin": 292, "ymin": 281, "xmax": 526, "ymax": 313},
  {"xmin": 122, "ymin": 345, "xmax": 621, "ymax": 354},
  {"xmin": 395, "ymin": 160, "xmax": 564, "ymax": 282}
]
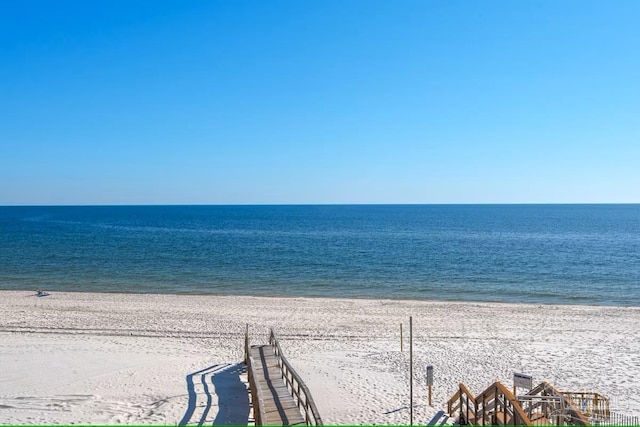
[{"xmin": 0, "ymin": 205, "xmax": 640, "ymax": 306}]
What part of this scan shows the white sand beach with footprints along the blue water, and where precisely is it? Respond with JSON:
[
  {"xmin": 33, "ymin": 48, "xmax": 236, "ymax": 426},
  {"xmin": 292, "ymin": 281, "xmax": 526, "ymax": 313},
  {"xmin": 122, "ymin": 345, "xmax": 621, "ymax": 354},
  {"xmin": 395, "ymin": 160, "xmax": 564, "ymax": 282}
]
[{"xmin": 0, "ymin": 291, "xmax": 640, "ymax": 425}]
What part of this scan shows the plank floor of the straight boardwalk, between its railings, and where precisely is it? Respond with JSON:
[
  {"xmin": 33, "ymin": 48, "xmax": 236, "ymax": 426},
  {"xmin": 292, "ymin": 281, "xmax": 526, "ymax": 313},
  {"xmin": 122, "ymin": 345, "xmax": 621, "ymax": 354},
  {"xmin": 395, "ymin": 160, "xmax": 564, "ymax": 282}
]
[{"xmin": 249, "ymin": 345, "xmax": 306, "ymax": 426}]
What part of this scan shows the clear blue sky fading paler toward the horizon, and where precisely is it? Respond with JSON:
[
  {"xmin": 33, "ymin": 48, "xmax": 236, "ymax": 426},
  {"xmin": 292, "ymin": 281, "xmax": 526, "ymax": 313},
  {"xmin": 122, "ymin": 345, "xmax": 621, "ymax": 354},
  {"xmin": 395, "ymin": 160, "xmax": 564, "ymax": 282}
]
[{"xmin": 0, "ymin": 0, "xmax": 640, "ymax": 205}]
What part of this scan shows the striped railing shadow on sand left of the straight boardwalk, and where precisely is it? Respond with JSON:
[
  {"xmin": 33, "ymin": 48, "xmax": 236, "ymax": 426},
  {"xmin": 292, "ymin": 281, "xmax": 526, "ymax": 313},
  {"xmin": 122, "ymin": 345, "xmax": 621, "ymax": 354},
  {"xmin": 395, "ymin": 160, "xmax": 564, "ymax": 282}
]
[{"xmin": 178, "ymin": 363, "xmax": 250, "ymax": 426}]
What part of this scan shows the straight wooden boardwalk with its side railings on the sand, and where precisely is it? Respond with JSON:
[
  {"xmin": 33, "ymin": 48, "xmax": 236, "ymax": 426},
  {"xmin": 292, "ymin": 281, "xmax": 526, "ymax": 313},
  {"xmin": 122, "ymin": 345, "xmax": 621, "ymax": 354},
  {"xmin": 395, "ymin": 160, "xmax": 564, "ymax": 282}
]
[{"xmin": 245, "ymin": 325, "xmax": 322, "ymax": 426}]
